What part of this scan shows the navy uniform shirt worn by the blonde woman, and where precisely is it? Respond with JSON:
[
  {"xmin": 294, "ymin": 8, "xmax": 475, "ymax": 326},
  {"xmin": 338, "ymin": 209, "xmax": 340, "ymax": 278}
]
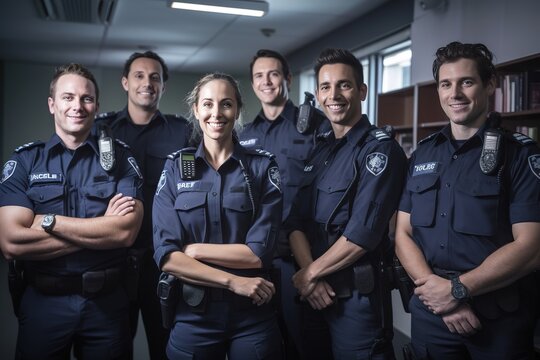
[{"xmin": 153, "ymin": 142, "xmax": 282, "ymax": 268}]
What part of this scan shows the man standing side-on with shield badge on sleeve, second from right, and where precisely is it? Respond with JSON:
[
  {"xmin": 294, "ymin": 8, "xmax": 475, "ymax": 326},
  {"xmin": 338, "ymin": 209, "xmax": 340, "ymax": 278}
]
[{"xmin": 287, "ymin": 49, "xmax": 406, "ymax": 359}]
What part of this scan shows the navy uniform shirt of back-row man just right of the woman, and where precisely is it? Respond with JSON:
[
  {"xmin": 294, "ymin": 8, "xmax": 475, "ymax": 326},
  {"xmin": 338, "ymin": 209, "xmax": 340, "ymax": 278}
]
[{"xmin": 239, "ymin": 100, "xmax": 331, "ymax": 220}]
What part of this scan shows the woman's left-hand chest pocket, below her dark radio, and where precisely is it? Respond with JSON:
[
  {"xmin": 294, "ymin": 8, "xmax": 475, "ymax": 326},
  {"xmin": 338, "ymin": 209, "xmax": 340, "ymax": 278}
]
[{"xmin": 174, "ymin": 191, "xmax": 207, "ymax": 243}]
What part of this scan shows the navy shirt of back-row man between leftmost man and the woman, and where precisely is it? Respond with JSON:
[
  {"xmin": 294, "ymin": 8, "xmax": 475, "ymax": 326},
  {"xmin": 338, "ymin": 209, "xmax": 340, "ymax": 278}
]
[{"xmin": 95, "ymin": 107, "xmax": 191, "ymax": 248}]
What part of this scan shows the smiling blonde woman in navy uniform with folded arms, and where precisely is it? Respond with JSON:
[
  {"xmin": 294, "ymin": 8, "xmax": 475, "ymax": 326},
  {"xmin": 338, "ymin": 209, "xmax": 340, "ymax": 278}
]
[{"xmin": 153, "ymin": 73, "xmax": 282, "ymax": 360}]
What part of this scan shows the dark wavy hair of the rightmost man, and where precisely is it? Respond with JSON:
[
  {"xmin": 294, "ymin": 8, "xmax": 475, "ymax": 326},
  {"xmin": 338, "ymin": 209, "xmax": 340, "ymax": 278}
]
[{"xmin": 433, "ymin": 41, "xmax": 497, "ymax": 86}]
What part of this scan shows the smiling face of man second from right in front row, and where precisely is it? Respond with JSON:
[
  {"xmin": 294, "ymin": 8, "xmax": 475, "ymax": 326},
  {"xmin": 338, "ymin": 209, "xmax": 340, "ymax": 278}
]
[{"xmin": 317, "ymin": 64, "xmax": 367, "ymax": 126}]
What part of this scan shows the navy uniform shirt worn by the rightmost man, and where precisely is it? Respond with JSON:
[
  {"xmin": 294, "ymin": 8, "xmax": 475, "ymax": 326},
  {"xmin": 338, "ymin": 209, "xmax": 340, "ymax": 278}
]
[{"xmin": 399, "ymin": 125, "xmax": 540, "ymax": 271}]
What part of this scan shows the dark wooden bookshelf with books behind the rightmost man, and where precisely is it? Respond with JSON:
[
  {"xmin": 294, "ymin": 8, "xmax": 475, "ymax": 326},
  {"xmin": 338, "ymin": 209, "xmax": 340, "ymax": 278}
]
[{"xmin": 377, "ymin": 53, "xmax": 540, "ymax": 150}]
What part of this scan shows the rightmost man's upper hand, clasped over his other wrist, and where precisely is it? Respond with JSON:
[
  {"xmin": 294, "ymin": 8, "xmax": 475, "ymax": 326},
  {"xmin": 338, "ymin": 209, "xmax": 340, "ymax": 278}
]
[{"xmin": 414, "ymin": 274, "xmax": 459, "ymax": 314}]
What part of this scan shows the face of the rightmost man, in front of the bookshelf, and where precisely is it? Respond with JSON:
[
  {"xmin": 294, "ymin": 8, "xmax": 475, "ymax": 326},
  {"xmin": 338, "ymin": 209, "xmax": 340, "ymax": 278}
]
[{"xmin": 437, "ymin": 58, "xmax": 495, "ymax": 131}]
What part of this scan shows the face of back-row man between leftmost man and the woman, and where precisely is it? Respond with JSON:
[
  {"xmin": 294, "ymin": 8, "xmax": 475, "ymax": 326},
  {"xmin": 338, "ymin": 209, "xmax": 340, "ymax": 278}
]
[{"xmin": 122, "ymin": 58, "xmax": 165, "ymax": 112}]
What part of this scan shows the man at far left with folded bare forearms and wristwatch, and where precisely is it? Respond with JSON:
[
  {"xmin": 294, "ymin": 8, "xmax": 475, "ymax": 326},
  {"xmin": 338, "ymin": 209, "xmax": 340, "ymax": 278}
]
[{"xmin": 0, "ymin": 64, "xmax": 143, "ymax": 359}]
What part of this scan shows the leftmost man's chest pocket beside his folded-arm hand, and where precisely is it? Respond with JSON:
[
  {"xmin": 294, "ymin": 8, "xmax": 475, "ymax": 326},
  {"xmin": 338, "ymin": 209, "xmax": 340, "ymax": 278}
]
[{"xmin": 79, "ymin": 182, "xmax": 116, "ymax": 217}]
